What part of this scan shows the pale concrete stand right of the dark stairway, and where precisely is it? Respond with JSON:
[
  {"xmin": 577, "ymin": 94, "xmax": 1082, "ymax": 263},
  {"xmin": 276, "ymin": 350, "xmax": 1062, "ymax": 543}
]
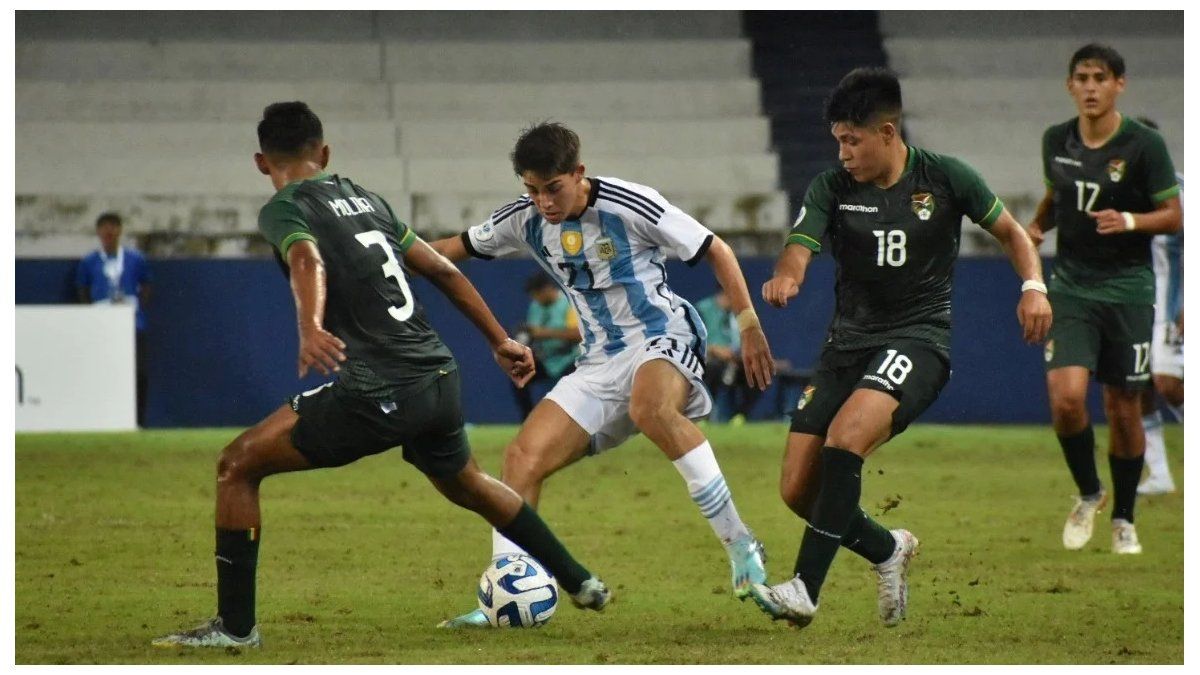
[{"xmin": 880, "ymin": 11, "xmax": 1183, "ymax": 252}]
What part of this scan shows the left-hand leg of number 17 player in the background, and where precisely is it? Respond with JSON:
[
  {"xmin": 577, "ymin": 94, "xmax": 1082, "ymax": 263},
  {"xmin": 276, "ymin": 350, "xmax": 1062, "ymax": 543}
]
[{"xmin": 1046, "ymin": 365, "xmax": 1108, "ymax": 550}]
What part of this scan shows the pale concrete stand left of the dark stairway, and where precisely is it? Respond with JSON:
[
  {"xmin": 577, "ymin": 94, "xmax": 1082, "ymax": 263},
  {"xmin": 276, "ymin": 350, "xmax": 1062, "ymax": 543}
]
[{"xmin": 16, "ymin": 11, "xmax": 790, "ymax": 256}]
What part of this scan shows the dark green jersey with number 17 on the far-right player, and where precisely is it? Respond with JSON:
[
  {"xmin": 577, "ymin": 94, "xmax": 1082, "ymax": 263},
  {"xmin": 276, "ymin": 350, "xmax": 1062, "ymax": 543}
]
[{"xmin": 1042, "ymin": 115, "xmax": 1180, "ymax": 305}]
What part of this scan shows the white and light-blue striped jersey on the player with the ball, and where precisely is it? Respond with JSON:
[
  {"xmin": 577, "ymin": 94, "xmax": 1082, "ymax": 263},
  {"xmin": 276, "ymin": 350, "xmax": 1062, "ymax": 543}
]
[{"xmin": 462, "ymin": 177, "xmax": 713, "ymax": 365}]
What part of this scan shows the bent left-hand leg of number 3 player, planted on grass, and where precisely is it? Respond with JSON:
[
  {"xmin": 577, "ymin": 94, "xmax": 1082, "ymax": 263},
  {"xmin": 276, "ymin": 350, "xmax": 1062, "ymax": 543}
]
[{"xmin": 152, "ymin": 406, "xmax": 313, "ymax": 647}]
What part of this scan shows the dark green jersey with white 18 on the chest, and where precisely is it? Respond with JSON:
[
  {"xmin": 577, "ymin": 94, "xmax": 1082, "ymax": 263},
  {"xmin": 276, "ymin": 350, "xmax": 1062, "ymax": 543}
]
[{"xmin": 787, "ymin": 147, "xmax": 1004, "ymax": 353}]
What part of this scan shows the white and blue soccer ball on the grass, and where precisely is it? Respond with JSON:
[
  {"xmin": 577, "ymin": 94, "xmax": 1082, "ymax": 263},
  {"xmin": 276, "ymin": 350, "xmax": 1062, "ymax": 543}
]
[{"xmin": 479, "ymin": 555, "xmax": 558, "ymax": 628}]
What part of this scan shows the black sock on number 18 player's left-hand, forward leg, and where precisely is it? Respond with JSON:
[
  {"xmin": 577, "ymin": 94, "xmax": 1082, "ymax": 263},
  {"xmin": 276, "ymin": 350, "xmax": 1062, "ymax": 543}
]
[{"xmin": 794, "ymin": 446, "xmax": 863, "ymax": 603}]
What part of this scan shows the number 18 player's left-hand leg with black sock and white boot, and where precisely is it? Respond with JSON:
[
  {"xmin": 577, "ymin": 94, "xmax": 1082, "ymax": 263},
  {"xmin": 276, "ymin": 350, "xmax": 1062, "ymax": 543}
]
[{"xmin": 751, "ymin": 389, "xmax": 904, "ymax": 627}]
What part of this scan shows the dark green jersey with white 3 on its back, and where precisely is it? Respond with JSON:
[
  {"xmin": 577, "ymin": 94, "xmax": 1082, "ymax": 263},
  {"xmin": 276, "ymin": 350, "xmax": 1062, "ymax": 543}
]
[{"xmin": 258, "ymin": 173, "xmax": 455, "ymax": 400}]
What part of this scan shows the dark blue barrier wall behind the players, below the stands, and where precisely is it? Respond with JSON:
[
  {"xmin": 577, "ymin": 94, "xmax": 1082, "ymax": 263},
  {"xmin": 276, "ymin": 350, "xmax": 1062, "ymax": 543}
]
[{"xmin": 16, "ymin": 256, "xmax": 1100, "ymax": 426}]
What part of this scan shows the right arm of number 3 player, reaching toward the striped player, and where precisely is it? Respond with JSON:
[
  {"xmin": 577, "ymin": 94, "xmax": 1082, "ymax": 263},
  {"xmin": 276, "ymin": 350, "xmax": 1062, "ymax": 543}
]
[{"xmin": 404, "ymin": 238, "xmax": 534, "ymax": 387}]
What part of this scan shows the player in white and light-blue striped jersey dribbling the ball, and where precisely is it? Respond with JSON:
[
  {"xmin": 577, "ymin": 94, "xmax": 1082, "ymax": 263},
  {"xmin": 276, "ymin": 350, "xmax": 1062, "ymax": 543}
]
[{"xmin": 433, "ymin": 123, "xmax": 774, "ymax": 627}]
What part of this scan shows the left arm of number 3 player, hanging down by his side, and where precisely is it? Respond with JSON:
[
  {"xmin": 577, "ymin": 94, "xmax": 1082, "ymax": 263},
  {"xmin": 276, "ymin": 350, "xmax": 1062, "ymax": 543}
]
[{"xmin": 288, "ymin": 240, "xmax": 346, "ymax": 377}]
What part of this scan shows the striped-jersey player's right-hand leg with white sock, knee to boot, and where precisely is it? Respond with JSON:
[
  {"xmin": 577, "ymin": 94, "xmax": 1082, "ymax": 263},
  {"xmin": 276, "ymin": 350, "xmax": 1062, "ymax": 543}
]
[{"xmin": 629, "ymin": 358, "xmax": 767, "ymax": 598}]
